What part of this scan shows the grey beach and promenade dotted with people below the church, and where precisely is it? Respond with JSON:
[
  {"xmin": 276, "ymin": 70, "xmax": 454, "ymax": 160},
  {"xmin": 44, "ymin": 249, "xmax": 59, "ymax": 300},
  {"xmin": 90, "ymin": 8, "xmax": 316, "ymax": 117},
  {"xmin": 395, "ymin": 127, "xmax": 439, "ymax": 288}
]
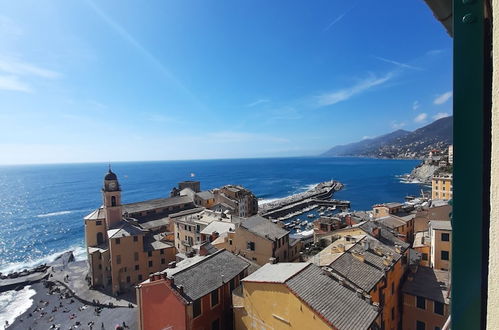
[{"xmin": 6, "ymin": 254, "xmax": 137, "ymax": 330}]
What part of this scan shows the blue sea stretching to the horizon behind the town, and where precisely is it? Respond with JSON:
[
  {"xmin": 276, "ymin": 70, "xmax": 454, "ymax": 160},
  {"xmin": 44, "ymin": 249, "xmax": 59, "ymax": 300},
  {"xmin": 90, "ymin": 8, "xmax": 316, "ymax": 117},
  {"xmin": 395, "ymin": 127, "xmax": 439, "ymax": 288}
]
[{"xmin": 0, "ymin": 158, "xmax": 421, "ymax": 272}]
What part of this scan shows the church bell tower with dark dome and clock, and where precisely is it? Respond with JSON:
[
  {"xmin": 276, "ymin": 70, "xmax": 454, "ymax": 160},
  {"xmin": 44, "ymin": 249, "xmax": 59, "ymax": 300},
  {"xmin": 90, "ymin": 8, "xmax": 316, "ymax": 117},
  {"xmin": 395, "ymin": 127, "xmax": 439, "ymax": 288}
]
[{"xmin": 102, "ymin": 166, "xmax": 123, "ymax": 229}]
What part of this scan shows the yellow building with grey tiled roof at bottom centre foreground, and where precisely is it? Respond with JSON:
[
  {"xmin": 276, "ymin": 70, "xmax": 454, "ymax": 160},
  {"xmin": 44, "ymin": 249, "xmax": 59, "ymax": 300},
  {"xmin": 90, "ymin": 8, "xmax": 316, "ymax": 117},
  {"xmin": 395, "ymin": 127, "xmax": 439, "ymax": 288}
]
[{"xmin": 233, "ymin": 263, "xmax": 380, "ymax": 330}]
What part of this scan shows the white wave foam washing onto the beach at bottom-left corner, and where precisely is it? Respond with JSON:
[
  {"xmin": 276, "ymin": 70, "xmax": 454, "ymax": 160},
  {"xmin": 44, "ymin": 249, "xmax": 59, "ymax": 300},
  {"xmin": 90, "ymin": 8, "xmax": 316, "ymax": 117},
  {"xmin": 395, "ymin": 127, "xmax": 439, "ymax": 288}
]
[{"xmin": 0, "ymin": 285, "xmax": 36, "ymax": 326}]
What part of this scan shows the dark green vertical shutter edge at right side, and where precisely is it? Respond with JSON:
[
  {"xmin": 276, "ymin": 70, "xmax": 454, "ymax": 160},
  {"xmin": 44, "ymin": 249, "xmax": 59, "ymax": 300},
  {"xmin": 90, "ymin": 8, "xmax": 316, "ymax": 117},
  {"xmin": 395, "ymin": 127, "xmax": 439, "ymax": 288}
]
[{"xmin": 451, "ymin": 0, "xmax": 490, "ymax": 330}]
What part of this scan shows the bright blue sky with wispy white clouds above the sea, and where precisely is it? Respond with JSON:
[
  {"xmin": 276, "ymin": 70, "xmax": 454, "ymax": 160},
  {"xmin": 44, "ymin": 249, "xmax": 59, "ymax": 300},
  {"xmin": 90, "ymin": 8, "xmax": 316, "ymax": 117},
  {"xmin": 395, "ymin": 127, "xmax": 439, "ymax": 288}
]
[{"xmin": 0, "ymin": 0, "xmax": 452, "ymax": 164}]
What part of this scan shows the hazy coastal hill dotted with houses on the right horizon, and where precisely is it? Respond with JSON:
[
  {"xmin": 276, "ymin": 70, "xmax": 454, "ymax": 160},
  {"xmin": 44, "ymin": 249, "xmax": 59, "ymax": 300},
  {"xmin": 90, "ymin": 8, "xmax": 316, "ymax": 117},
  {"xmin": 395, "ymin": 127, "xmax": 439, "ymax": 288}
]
[{"xmin": 321, "ymin": 116, "xmax": 452, "ymax": 159}]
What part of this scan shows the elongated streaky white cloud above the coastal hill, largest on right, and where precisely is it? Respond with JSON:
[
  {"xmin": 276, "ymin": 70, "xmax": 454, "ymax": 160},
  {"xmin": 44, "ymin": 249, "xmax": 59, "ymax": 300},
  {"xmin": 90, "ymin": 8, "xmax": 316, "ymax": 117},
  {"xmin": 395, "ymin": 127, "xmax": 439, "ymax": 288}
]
[{"xmin": 317, "ymin": 72, "xmax": 394, "ymax": 106}]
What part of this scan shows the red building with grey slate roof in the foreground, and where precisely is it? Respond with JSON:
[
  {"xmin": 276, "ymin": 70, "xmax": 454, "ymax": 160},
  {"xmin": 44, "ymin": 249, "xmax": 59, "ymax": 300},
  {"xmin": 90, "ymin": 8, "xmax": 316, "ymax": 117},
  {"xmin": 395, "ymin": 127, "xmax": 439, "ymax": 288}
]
[{"xmin": 137, "ymin": 249, "xmax": 250, "ymax": 330}]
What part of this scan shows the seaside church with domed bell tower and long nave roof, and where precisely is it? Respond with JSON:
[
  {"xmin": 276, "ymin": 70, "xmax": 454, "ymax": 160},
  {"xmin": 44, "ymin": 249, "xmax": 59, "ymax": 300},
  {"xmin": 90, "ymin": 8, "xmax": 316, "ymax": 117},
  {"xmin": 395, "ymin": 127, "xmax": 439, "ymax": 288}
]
[{"xmin": 84, "ymin": 169, "xmax": 194, "ymax": 294}]
